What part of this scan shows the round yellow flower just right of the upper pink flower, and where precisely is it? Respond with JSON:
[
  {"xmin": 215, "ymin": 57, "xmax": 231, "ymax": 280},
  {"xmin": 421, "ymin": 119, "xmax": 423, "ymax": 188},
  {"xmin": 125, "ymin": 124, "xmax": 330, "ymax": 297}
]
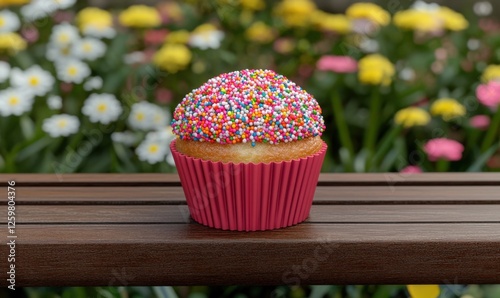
[{"xmin": 358, "ymin": 54, "xmax": 395, "ymax": 86}]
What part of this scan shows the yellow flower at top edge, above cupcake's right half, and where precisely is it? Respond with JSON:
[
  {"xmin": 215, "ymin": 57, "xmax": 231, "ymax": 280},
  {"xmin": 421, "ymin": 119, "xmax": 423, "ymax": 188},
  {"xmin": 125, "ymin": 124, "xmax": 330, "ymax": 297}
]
[{"xmin": 275, "ymin": 0, "xmax": 316, "ymax": 27}]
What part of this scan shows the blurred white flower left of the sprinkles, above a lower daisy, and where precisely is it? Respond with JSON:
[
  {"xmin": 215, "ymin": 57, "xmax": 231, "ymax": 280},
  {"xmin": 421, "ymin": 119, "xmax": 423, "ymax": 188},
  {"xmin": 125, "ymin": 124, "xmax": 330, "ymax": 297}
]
[{"xmin": 128, "ymin": 101, "xmax": 170, "ymax": 130}]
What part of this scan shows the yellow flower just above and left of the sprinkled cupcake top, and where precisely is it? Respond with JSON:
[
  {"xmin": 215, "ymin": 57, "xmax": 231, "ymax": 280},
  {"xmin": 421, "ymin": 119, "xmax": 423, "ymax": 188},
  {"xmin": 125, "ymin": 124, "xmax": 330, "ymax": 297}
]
[{"xmin": 153, "ymin": 44, "xmax": 192, "ymax": 73}]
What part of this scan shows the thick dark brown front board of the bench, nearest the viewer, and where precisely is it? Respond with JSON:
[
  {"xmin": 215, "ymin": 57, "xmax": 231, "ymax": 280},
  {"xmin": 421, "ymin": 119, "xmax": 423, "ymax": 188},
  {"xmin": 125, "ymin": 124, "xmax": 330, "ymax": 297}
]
[{"xmin": 6, "ymin": 223, "xmax": 500, "ymax": 286}]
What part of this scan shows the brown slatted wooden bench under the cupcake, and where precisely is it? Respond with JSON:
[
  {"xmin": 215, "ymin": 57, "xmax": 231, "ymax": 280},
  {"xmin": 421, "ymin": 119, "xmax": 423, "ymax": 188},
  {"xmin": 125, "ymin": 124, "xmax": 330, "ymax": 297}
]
[{"xmin": 0, "ymin": 173, "xmax": 500, "ymax": 287}]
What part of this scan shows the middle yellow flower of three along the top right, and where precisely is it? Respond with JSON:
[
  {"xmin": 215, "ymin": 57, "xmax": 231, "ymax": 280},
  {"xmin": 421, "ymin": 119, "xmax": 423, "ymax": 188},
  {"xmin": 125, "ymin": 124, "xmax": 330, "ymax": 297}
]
[{"xmin": 394, "ymin": 9, "xmax": 441, "ymax": 32}]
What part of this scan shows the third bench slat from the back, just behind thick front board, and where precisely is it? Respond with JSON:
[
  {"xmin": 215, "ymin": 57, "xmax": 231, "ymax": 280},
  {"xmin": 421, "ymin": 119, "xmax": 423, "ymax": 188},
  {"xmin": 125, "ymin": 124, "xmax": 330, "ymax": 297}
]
[{"xmin": 5, "ymin": 205, "xmax": 500, "ymax": 225}]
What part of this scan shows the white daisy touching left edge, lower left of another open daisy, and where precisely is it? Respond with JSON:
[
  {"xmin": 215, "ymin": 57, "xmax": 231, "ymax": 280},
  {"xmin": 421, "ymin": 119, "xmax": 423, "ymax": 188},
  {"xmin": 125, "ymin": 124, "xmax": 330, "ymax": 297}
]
[{"xmin": 0, "ymin": 88, "xmax": 34, "ymax": 116}]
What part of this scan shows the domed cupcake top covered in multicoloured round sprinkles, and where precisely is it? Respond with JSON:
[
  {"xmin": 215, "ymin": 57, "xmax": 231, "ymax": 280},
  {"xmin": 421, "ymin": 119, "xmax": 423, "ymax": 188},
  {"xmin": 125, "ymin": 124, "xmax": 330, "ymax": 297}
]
[{"xmin": 172, "ymin": 69, "xmax": 325, "ymax": 145}]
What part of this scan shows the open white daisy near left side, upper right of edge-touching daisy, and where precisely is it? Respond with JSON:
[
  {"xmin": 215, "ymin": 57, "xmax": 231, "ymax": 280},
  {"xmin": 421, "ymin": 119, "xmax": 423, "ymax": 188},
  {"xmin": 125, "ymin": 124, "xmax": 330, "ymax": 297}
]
[{"xmin": 10, "ymin": 65, "xmax": 55, "ymax": 96}]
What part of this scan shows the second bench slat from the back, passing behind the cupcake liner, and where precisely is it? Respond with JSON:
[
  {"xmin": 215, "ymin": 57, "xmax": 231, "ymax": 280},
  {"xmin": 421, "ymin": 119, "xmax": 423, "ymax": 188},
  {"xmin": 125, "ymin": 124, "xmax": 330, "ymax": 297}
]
[{"xmin": 8, "ymin": 186, "xmax": 500, "ymax": 205}]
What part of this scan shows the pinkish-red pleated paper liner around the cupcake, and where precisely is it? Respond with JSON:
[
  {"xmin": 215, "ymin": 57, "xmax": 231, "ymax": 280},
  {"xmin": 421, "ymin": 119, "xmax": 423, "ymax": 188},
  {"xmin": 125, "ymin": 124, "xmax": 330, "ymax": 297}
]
[{"xmin": 170, "ymin": 140, "xmax": 327, "ymax": 231}]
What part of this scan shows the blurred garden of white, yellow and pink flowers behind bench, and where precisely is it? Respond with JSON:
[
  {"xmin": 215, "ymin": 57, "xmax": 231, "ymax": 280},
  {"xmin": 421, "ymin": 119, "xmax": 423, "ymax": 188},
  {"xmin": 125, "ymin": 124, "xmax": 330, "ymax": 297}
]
[{"xmin": 0, "ymin": 0, "xmax": 500, "ymax": 298}]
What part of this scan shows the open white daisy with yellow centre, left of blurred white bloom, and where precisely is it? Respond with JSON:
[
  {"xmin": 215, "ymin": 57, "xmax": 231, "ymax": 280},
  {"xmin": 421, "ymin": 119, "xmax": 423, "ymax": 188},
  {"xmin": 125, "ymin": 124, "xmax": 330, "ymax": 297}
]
[{"xmin": 82, "ymin": 93, "xmax": 123, "ymax": 124}]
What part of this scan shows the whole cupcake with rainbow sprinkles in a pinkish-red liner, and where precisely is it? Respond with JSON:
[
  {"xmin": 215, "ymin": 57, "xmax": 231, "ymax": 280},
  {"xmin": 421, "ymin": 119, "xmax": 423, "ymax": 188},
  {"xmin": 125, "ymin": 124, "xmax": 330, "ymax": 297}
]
[{"xmin": 170, "ymin": 70, "xmax": 326, "ymax": 231}]
